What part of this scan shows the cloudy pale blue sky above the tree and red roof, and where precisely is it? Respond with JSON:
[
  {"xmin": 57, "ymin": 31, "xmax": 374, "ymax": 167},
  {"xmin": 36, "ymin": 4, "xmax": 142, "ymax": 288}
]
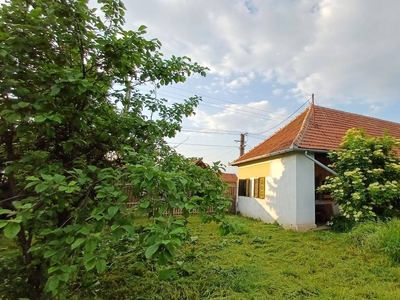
[{"xmin": 110, "ymin": 0, "xmax": 400, "ymax": 172}]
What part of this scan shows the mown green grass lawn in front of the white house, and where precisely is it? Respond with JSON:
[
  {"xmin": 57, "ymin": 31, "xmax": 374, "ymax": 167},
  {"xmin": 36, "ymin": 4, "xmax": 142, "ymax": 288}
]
[{"xmin": 85, "ymin": 216, "xmax": 400, "ymax": 299}]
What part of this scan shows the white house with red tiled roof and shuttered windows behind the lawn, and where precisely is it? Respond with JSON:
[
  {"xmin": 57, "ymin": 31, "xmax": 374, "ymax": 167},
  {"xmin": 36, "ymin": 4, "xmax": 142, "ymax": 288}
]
[{"xmin": 231, "ymin": 105, "xmax": 400, "ymax": 231}]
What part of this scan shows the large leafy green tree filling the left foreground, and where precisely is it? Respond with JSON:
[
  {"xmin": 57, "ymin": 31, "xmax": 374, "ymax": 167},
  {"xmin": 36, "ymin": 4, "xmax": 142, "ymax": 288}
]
[{"xmin": 0, "ymin": 0, "xmax": 229, "ymax": 299}]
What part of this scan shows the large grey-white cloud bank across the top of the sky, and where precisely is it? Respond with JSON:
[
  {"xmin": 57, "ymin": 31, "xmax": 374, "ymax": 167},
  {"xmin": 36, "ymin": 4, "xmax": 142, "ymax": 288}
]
[{"xmin": 120, "ymin": 0, "xmax": 400, "ymax": 104}]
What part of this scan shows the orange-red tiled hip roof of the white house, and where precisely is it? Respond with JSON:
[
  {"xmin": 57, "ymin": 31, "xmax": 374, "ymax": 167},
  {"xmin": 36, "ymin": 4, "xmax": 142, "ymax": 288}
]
[{"xmin": 232, "ymin": 105, "xmax": 400, "ymax": 165}]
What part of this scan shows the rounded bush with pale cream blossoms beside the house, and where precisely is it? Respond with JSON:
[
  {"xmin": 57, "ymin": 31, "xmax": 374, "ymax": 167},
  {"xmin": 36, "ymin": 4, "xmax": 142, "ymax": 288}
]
[{"xmin": 320, "ymin": 129, "xmax": 400, "ymax": 225}]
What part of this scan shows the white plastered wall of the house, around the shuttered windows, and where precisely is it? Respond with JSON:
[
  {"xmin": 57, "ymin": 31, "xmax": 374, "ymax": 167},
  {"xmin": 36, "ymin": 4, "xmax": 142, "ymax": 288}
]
[{"xmin": 238, "ymin": 152, "xmax": 315, "ymax": 231}]
